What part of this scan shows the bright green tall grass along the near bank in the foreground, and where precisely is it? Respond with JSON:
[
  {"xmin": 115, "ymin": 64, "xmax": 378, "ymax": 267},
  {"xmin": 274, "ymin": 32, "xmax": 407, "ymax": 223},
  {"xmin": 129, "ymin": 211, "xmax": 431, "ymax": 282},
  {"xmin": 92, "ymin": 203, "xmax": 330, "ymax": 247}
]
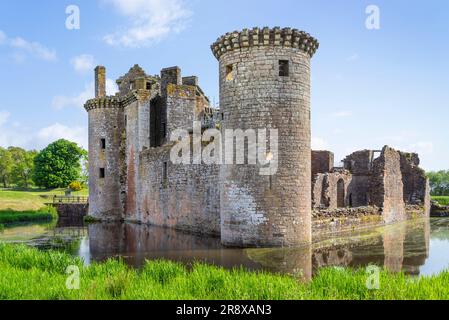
[{"xmin": 0, "ymin": 244, "xmax": 449, "ymax": 300}]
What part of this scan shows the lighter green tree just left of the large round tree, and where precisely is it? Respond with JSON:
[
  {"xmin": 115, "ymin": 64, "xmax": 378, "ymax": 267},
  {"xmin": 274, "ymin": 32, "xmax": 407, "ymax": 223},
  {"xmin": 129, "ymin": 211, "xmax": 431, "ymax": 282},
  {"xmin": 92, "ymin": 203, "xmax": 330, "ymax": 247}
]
[{"xmin": 8, "ymin": 147, "xmax": 38, "ymax": 188}]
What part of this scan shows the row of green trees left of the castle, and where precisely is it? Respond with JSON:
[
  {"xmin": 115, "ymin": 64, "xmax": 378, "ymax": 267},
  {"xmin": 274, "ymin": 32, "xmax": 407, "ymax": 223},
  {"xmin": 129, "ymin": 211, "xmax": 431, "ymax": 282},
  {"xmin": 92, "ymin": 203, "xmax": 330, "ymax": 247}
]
[{"xmin": 0, "ymin": 139, "xmax": 88, "ymax": 189}]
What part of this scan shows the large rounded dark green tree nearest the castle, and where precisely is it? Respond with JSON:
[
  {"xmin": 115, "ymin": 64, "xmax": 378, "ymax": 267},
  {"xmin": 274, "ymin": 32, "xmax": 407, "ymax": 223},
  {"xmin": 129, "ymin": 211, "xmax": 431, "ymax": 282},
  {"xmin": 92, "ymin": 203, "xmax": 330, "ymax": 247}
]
[{"xmin": 34, "ymin": 139, "xmax": 86, "ymax": 189}]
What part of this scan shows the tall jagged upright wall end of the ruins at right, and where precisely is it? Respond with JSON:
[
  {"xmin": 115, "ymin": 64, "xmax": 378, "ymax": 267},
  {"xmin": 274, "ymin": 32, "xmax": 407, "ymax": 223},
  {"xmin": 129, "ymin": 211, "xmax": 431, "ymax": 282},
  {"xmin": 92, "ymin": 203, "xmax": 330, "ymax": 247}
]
[{"xmin": 370, "ymin": 147, "xmax": 405, "ymax": 223}]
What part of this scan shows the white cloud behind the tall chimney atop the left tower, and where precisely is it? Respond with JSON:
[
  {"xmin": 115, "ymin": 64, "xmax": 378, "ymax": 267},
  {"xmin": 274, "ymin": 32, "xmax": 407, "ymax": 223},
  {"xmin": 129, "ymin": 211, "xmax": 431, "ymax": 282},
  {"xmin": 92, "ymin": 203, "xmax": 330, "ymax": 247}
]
[{"xmin": 51, "ymin": 79, "xmax": 118, "ymax": 110}]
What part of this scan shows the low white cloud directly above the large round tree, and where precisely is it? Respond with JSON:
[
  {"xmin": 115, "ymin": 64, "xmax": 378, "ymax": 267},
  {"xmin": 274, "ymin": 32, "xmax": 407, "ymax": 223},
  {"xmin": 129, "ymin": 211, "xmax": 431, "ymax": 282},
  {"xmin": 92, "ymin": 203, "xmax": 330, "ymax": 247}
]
[{"xmin": 37, "ymin": 123, "xmax": 88, "ymax": 148}]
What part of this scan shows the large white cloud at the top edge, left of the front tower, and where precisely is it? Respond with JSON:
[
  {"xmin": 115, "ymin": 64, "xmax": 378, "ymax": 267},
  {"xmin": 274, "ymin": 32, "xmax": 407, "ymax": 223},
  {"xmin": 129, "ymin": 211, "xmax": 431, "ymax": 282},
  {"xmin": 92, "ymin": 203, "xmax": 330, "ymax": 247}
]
[{"xmin": 103, "ymin": 0, "xmax": 192, "ymax": 48}]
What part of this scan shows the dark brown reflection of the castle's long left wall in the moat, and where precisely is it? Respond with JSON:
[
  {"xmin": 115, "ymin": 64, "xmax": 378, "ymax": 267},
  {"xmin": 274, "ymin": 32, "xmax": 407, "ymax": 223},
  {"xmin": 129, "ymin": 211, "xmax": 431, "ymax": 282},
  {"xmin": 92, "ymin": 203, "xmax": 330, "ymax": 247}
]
[{"xmin": 89, "ymin": 223, "xmax": 258, "ymax": 269}]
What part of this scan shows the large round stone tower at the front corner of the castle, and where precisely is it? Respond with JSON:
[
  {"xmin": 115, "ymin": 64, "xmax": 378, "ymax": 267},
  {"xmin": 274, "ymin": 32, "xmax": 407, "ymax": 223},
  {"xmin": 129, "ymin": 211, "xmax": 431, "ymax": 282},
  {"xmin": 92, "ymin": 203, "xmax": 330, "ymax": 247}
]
[{"xmin": 211, "ymin": 27, "xmax": 318, "ymax": 247}]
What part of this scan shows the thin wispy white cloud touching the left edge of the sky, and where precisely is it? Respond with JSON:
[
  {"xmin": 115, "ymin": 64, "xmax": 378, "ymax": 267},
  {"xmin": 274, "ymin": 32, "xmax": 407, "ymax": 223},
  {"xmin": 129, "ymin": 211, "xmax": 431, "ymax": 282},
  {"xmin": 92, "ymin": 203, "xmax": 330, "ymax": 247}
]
[{"xmin": 0, "ymin": 30, "xmax": 56, "ymax": 61}]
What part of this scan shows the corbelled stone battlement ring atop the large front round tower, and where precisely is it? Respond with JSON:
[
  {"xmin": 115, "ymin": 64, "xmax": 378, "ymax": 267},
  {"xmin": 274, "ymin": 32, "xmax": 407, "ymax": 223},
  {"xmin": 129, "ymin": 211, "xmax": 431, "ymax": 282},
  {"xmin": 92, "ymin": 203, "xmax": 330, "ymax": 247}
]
[{"xmin": 211, "ymin": 27, "xmax": 319, "ymax": 59}]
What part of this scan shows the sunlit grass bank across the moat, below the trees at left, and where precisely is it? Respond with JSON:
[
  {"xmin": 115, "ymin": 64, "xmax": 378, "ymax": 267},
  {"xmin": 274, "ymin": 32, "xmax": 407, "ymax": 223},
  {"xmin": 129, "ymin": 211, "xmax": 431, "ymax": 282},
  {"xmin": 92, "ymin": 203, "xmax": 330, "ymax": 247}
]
[{"xmin": 0, "ymin": 189, "xmax": 89, "ymax": 211}]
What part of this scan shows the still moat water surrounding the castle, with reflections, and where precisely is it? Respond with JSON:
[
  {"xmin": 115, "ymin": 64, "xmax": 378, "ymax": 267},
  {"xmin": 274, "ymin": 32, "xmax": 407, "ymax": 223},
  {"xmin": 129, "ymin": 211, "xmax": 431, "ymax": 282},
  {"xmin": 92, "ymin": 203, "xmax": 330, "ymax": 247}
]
[{"xmin": 0, "ymin": 218, "xmax": 449, "ymax": 278}]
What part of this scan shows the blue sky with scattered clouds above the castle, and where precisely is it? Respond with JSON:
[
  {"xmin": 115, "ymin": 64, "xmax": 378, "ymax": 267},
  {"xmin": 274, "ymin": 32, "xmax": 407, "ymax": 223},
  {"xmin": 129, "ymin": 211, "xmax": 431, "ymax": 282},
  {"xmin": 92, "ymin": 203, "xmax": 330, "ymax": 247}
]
[{"xmin": 0, "ymin": 0, "xmax": 449, "ymax": 170}]
